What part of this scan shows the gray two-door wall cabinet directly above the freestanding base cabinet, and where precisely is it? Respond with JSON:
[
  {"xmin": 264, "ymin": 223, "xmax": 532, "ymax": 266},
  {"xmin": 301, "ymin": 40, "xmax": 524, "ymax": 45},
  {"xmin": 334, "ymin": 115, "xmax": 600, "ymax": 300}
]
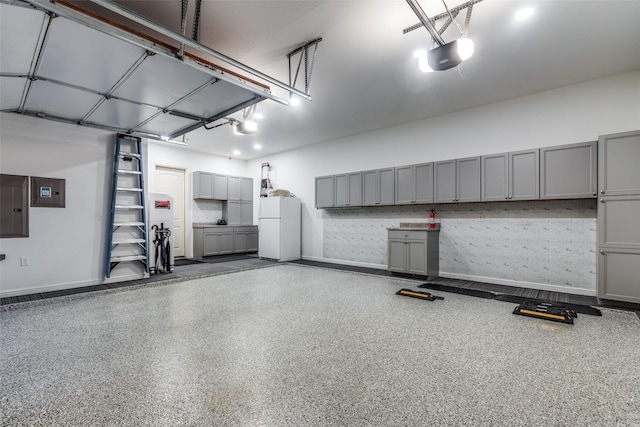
[{"xmin": 395, "ymin": 163, "xmax": 433, "ymax": 205}]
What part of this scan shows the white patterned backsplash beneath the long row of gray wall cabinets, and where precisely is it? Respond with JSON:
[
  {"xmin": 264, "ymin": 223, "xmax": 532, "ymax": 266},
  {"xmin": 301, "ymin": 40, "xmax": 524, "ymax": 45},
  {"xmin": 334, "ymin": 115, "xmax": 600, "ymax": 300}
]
[{"xmin": 323, "ymin": 199, "xmax": 597, "ymax": 291}]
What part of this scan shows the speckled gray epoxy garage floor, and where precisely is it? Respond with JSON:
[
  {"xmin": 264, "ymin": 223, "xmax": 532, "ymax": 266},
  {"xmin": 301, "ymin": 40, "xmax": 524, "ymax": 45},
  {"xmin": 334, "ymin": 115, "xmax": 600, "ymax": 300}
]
[{"xmin": 0, "ymin": 265, "xmax": 640, "ymax": 426}]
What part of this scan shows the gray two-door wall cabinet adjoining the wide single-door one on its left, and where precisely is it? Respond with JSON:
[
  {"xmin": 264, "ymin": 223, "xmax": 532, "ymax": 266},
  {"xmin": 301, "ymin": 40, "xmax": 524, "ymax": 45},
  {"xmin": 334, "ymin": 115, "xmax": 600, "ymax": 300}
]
[{"xmin": 481, "ymin": 149, "xmax": 540, "ymax": 202}]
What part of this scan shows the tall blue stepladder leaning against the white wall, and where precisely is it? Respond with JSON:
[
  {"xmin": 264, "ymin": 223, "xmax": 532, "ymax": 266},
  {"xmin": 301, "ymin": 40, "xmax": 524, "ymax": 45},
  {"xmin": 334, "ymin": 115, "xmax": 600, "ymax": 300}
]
[{"xmin": 106, "ymin": 134, "xmax": 149, "ymax": 278}]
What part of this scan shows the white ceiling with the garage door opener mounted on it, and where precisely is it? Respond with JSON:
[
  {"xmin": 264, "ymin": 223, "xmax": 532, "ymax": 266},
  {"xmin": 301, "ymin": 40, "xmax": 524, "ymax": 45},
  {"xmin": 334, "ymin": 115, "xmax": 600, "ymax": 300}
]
[{"xmin": 10, "ymin": 0, "xmax": 640, "ymax": 159}]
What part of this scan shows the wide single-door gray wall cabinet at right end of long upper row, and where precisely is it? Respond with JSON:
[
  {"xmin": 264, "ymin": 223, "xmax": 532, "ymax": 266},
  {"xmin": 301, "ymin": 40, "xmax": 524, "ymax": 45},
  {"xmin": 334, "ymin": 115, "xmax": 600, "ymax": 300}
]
[{"xmin": 540, "ymin": 141, "xmax": 598, "ymax": 199}]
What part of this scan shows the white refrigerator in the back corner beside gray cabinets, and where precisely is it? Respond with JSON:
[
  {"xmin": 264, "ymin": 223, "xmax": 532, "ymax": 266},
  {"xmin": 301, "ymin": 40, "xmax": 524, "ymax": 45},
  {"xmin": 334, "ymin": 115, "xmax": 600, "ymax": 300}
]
[{"xmin": 258, "ymin": 197, "xmax": 301, "ymax": 261}]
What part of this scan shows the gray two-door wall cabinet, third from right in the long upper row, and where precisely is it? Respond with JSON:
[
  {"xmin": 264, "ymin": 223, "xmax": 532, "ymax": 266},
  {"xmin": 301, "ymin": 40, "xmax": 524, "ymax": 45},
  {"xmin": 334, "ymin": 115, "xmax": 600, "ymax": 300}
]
[{"xmin": 434, "ymin": 157, "xmax": 480, "ymax": 203}]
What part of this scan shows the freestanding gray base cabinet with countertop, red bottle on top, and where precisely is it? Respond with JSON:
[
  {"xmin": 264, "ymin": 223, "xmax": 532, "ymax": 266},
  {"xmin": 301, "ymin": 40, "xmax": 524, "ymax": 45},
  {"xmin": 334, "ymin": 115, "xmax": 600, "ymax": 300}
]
[{"xmin": 387, "ymin": 229, "xmax": 440, "ymax": 277}]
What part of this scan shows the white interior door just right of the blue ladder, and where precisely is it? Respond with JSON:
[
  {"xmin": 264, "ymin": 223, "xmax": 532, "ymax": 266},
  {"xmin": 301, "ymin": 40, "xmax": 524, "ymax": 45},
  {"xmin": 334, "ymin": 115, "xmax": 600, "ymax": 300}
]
[{"xmin": 152, "ymin": 165, "xmax": 185, "ymax": 257}]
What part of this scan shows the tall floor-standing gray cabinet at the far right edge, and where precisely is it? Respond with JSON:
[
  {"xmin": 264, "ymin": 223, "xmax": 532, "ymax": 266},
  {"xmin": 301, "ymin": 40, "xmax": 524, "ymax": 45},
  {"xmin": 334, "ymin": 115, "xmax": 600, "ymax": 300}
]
[{"xmin": 597, "ymin": 131, "xmax": 640, "ymax": 304}]
